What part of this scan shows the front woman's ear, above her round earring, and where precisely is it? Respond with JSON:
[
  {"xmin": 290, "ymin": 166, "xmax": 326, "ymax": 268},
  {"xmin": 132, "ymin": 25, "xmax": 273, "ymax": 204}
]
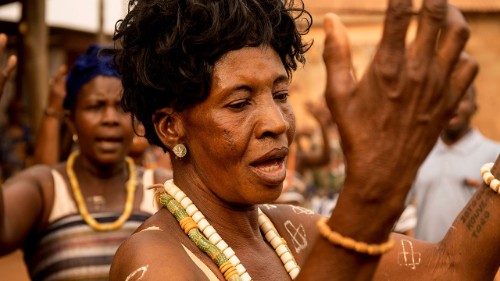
[{"xmin": 153, "ymin": 107, "xmax": 185, "ymax": 150}]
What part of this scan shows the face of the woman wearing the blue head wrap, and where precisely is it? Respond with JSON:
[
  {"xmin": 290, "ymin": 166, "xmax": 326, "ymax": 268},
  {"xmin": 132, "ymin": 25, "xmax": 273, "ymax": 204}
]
[{"xmin": 72, "ymin": 76, "xmax": 133, "ymax": 164}]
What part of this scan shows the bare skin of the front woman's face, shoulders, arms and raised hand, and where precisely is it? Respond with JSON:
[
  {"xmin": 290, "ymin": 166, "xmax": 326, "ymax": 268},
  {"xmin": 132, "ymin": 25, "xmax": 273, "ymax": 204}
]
[{"xmin": 111, "ymin": 0, "xmax": 500, "ymax": 280}]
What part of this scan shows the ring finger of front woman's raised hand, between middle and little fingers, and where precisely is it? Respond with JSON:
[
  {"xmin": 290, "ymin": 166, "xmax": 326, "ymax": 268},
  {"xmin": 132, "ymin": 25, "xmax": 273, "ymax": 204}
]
[{"xmin": 436, "ymin": 6, "xmax": 470, "ymax": 75}]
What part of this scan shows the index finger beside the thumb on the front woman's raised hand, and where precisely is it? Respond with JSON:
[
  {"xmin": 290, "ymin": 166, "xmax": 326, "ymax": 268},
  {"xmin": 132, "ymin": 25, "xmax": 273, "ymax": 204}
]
[{"xmin": 375, "ymin": 0, "xmax": 412, "ymax": 81}]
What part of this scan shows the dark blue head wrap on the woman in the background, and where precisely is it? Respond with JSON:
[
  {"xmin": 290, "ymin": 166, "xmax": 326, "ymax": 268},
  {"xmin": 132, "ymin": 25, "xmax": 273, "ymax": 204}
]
[{"xmin": 63, "ymin": 45, "xmax": 120, "ymax": 109}]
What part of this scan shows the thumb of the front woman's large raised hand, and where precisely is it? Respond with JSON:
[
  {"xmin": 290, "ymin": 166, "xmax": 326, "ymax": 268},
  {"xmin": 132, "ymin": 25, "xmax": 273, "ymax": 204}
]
[{"xmin": 323, "ymin": 13, "xmax": 356, "ymax": 109}]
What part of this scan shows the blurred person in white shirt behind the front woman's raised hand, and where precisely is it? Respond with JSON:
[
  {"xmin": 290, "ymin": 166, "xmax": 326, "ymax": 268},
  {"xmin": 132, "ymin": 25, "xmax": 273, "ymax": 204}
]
[{"xmin": 408, "ymin": 82, "xmax": 500, "ymax": 242}]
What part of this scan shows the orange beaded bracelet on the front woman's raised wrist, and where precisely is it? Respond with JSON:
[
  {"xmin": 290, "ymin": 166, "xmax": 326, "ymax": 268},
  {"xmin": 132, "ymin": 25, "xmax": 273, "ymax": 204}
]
[{"xmin": 317, "ymin": 218, "xmax": 394, "ymax": 256}]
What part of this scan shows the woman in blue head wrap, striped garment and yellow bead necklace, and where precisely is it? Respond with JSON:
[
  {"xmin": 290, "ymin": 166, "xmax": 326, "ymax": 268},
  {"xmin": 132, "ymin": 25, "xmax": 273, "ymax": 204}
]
[{"xmin": 0, "ymin": 46, "xmax": 169, "ymax": 280}]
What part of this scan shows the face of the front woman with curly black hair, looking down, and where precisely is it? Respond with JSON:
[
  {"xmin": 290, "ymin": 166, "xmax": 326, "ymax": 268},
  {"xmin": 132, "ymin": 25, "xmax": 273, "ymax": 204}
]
[{"xmin": 182, "ymin": 46, "xmax": 295, "ymax": 205}]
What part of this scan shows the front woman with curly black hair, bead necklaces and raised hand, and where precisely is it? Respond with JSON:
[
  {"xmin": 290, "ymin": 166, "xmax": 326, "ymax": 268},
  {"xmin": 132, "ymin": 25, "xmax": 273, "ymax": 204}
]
[{"xmin": 111, "ymin": 0, "xmax": 500, "ymax": 281}]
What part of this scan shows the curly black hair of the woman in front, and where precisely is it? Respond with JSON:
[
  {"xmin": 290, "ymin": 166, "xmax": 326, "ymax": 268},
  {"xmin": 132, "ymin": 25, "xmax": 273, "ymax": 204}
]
[{"xmin": 113, "ymin": 0, "xmax": 312, "ymax": 149}]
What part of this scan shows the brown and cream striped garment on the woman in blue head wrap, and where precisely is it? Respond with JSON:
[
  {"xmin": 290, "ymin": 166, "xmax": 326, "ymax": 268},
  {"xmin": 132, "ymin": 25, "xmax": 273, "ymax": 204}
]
[{"xmin": 24, "ymin": 168, "xmax": 155, "ymax": 281}]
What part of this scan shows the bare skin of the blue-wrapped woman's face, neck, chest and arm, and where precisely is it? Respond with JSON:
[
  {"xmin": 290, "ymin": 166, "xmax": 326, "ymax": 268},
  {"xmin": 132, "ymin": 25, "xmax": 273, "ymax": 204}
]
[{"xmin": 0, "ymin": 71, "xmax": 170, "ymax": 255}]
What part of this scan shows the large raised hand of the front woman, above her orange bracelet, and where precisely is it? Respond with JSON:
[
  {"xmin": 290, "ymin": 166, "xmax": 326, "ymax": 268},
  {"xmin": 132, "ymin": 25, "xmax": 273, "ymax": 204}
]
[{"xmin": 323, "ymin": 0, "xmax": 478, "ymax": 207}]
